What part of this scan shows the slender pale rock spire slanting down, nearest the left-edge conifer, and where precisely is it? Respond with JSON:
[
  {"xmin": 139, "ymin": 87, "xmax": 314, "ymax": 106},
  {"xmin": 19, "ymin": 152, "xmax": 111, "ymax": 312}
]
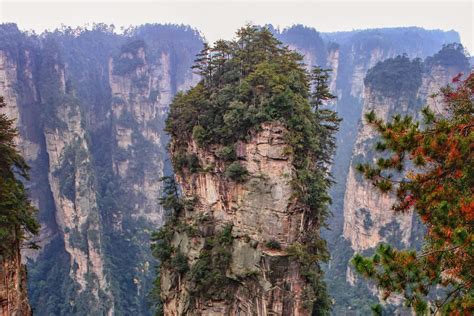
[{"xmin": 45, "ymin": 92, "xmax": 114, "ymax": 315}]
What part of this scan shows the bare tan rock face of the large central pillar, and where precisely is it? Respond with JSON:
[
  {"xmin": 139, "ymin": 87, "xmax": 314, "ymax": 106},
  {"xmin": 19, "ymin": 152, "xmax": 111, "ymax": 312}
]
[{"xmin": 161, "ymin": 122, "xmax": 310, "ymax": 315}]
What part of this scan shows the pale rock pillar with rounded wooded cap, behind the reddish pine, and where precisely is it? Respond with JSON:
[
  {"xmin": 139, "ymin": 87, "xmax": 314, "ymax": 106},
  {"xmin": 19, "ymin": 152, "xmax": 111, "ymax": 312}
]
[{"xmin": 343, "ymin": 56, "xmax": 426, "ymax": 252}]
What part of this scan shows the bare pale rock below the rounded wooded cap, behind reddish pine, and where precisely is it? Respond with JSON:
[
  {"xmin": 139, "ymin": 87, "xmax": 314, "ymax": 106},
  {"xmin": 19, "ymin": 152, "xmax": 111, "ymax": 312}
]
[{"xmin": 343, "ymin": 88, "xmax": 416, "ymax": 252}]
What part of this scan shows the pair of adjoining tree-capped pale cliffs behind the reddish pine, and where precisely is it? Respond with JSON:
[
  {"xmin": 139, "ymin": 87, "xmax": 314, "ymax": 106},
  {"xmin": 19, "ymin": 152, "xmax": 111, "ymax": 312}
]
[{"xmin": 343, "ymin": 47, "xmax": 469, "ymax": 251}]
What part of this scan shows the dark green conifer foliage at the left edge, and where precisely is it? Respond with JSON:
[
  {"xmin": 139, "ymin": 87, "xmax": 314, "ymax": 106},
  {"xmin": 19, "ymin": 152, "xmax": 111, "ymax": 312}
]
[{"xmin": 0, "ymin": 97, "xmax": 39, "ymax": 257}]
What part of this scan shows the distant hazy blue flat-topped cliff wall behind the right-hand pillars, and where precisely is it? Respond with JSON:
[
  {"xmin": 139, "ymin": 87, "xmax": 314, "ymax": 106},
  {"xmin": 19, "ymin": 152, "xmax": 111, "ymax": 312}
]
[{"xmin": 277, "ymin": 26, "xmax": 459, "ymax": 242}]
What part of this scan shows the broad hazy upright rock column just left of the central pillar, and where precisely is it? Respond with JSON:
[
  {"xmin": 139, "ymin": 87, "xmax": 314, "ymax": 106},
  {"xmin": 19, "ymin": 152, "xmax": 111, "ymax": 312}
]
[{"xmin": 109, "ymin": 47, "xmax": 197, "ymax": 226}]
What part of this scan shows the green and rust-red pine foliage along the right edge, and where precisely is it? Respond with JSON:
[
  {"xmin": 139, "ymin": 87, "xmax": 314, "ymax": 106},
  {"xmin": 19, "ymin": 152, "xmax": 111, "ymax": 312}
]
[{"xmin": 353, "ymin": 73, "xmax": 474, "ymax": 315}]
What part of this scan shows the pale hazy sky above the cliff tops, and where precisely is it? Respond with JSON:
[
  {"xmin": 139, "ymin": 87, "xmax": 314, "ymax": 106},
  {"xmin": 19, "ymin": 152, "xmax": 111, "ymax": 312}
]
[{"xmin": 0, "ymin": 0, "xmax": 474, "ymax": 53}]
